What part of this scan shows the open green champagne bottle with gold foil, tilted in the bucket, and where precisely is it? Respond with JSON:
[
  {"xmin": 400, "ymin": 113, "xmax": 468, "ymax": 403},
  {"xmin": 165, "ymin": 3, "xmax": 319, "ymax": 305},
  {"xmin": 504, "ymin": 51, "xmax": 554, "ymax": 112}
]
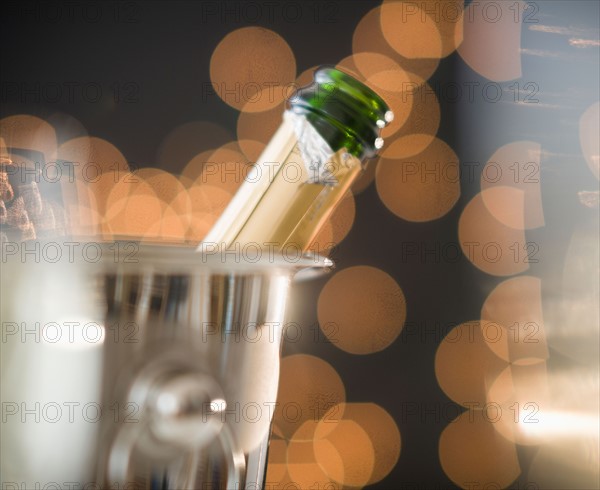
[{"xmin": 199, "ymin": 67, "xmax": 394, "ymax": 252}]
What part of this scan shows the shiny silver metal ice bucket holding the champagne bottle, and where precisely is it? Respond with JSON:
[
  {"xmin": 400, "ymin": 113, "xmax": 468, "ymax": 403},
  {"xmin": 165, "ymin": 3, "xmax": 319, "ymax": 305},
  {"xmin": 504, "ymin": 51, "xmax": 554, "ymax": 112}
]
[{"xmin": 3, "ymin": 243, "xmax": 331, "ymax": 490}]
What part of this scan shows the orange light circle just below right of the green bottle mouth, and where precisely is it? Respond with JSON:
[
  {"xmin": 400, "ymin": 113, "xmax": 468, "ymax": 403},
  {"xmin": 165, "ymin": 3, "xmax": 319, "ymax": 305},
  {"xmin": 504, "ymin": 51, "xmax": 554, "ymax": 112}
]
[{"xmin": 375, "ymin": 138, "xmax": 460, "ymax": 221}]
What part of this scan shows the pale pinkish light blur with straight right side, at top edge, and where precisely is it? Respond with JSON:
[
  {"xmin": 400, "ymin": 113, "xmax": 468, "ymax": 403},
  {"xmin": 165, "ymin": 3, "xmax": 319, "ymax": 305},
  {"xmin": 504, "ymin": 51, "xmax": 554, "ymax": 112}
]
[{"xmin": 457, "ymin": 0, "xmax": 528, "ymax": 82}]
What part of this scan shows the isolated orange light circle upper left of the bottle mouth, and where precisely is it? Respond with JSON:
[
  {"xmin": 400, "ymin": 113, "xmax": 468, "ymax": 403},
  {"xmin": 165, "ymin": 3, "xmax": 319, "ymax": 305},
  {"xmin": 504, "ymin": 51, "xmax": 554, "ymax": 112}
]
[{"xmin": 210, "ymin": 27, "xmax": 296, "ymax": 112}]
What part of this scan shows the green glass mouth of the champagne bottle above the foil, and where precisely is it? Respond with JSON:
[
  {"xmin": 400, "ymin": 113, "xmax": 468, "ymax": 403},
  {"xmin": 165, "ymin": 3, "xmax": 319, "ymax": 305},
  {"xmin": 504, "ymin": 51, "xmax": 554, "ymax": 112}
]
[{"xmin": 290, "ymin": 66, "xmax": 394, "ymax": 158}]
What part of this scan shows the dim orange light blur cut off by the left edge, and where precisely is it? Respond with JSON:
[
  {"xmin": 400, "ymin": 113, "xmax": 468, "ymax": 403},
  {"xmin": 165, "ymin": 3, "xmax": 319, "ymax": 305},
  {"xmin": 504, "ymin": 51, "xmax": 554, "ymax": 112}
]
[{"xmin": 0, "ymin": 114, "xmax": 57, "ymax": 162}]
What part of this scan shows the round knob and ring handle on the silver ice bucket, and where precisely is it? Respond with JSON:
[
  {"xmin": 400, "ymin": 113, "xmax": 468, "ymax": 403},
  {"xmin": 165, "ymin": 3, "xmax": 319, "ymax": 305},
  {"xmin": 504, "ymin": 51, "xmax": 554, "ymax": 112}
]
[{"xmin": 106, "ymin": 362, "xmax": 246, "ymax": 489}]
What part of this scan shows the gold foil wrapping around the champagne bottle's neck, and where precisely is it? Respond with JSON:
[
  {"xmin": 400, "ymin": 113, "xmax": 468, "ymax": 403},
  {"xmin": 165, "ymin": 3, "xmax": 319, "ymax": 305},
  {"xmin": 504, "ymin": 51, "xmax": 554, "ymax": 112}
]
[{"xmin": 204, "ymin": 112, "xmax": 362, "ymax": 252}]
